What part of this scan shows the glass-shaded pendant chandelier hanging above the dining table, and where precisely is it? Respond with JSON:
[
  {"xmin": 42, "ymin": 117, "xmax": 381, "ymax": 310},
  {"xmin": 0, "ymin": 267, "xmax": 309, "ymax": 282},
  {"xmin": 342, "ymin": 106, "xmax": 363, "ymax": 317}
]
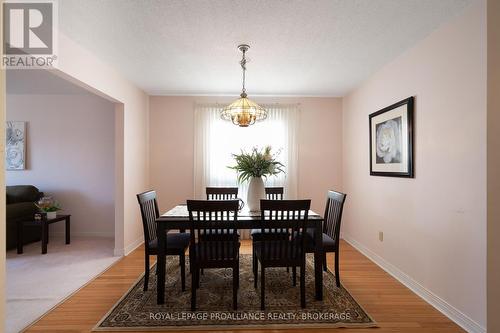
[{"xmin": 221, "ymin": 44, "xmax": 267, "ymax": 127}]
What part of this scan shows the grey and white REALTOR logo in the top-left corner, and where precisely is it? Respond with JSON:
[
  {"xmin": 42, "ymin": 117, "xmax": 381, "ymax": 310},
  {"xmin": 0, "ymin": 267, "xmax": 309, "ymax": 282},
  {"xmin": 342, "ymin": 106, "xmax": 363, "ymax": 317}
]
[{"xmin": 2, "ymin": 0, "xmax": 57, "ymax": 68}]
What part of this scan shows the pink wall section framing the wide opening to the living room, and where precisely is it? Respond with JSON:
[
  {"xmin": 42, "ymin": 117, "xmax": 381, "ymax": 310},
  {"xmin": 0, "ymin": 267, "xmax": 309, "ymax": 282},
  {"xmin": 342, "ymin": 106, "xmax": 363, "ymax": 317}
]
[{"xmin": 55, "ymin": 32, "xmax": 149, "ymax": 255}]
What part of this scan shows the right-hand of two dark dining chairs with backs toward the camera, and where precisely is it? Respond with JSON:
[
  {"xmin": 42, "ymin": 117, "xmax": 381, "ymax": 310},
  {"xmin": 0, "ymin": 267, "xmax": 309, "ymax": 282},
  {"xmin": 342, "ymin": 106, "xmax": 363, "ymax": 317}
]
[{"xmin": 253, "ymin": 200, "xmax": 311, "ymax": 310}]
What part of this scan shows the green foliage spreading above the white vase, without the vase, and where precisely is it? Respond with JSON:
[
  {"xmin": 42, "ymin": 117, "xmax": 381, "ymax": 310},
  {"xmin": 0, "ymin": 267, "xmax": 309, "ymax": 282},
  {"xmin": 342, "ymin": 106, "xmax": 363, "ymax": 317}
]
[{"xmin": 228, "ymin": 146, "xmax": 285, "ymax": 183}]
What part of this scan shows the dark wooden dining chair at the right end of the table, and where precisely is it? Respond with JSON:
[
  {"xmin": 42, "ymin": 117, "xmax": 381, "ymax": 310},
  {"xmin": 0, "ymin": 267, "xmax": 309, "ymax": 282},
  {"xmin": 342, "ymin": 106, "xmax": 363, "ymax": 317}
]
[{"xmin": 306, "ymin": 191, "xmax": 347, "ymax": 287}]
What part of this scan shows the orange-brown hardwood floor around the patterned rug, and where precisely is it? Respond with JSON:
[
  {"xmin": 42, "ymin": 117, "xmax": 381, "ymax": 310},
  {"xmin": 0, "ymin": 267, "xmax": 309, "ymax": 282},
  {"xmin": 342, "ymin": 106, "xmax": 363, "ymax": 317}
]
[{"xmin": 27, "ymin": 241, "xmax": 465, "ymax": 333}]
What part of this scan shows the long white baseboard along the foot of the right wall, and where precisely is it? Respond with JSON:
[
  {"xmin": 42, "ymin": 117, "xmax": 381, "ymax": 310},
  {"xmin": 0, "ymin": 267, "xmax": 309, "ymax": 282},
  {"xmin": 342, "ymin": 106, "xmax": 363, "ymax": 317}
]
[{"xmin": 342, "ymin": 233, "xmax": 486, "ymax": 333}]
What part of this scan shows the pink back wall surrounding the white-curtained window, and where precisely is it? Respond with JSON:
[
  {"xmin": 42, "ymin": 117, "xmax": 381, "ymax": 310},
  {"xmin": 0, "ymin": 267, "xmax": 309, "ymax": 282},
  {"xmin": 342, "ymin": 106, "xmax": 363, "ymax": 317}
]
[{"xmin": 149, "ymin": 96, "xmax": 342, "ymax": 212}]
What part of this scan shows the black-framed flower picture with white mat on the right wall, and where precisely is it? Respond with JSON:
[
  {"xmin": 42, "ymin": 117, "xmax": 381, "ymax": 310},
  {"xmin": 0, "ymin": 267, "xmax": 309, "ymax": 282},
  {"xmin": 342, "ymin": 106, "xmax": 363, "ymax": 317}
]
[{"xmin": 370, "ymin": 97, "xmax": 414, "ymax": 178}]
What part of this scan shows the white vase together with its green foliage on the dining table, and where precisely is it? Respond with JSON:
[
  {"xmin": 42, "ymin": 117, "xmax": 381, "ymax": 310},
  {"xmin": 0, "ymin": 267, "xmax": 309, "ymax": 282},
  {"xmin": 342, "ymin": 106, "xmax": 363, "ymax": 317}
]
[{"xmin": 228, "ymin": 146, "xmax": 285, "ymax": 211}]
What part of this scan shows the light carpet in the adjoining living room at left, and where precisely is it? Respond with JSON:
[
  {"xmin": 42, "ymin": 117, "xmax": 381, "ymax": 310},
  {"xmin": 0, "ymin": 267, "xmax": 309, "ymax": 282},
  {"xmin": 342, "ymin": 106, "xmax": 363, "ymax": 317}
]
[{"xmin": 5, "ymin": 236, "xmax": 119, "ymax": 333}]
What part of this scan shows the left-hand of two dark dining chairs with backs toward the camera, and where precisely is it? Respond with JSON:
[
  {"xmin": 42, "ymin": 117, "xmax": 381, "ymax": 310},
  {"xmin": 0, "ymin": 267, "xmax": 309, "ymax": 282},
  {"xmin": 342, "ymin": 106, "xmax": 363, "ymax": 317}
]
[{"xmin": 187, "ymin": 200, "xmax": 240, "ymax": 311}]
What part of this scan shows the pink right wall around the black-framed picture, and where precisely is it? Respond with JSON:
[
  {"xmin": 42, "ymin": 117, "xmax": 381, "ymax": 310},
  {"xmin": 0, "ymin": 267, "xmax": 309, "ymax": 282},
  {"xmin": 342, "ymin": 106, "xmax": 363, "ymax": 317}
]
[{"xmin": 343, "ymin": 1, "xmax": 486, "ymax": 331}]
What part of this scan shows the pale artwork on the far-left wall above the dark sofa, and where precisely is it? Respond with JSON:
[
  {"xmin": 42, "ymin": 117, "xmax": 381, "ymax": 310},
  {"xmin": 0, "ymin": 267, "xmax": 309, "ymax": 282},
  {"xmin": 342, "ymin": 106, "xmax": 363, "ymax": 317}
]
[{"xmin": 5, "ymin": 121, "xmax": 26, "ymax": 170}]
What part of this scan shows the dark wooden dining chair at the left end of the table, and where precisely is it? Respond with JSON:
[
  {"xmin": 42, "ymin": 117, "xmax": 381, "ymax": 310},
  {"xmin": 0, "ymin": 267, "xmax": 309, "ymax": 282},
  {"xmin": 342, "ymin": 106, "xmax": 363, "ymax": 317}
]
[{"xmin": 137, "ymin": 191, "xmax": 190, "ymax": 291}]
